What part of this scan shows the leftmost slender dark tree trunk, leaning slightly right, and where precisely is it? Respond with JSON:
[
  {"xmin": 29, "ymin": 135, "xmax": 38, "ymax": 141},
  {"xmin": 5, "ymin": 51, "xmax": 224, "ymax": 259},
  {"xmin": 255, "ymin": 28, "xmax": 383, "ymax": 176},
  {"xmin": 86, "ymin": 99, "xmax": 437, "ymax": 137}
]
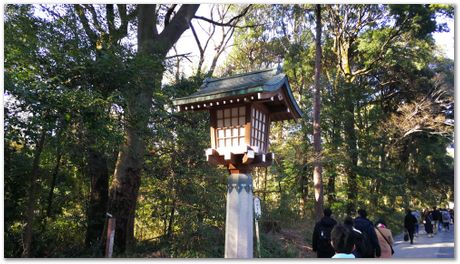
[{"xmin": 22, "ymin": 129, "xmax": 46, "ymax": 258}]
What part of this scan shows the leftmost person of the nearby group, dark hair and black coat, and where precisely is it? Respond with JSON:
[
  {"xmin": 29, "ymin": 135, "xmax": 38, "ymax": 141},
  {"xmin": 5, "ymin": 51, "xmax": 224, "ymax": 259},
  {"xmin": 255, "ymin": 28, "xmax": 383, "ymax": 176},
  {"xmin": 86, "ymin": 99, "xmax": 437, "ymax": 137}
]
[{"xmin": 312, "ymin": 208, "xmax": 337, "ymax": 258}]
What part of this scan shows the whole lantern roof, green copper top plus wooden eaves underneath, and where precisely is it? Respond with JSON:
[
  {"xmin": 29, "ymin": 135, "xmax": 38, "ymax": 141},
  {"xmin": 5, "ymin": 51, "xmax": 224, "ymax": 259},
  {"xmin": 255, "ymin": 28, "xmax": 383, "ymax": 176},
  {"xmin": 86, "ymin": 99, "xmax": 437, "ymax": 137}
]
[{"xmin": 173, "ymin": 67, "xmax": 302, "ymax": 121}]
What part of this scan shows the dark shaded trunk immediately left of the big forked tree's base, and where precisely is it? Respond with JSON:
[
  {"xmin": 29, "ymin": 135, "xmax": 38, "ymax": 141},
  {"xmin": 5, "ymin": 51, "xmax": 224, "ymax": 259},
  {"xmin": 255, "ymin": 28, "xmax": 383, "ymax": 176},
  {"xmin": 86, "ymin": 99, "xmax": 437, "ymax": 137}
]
[{"xmin": 85, "ymin": 147, "xmax": 109, "ymax": 253}]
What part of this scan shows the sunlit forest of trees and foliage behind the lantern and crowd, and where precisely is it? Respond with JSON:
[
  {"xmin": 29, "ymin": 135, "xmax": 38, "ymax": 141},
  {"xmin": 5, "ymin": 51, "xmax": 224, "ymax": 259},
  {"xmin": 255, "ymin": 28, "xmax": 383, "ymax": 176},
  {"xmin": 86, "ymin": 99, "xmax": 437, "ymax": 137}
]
[{"xmin": 2, "ymin": 4, "xmax": 454, "ymax": 258}]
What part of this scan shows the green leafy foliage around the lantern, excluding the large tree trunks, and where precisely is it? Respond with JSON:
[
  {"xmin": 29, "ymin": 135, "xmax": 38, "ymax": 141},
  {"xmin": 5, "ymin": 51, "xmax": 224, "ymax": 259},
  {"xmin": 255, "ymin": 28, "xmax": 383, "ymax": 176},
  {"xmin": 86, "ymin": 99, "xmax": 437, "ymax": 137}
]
[{"xmin": 4, "ymin": 4, "xmax": 454, "ymax": 258}]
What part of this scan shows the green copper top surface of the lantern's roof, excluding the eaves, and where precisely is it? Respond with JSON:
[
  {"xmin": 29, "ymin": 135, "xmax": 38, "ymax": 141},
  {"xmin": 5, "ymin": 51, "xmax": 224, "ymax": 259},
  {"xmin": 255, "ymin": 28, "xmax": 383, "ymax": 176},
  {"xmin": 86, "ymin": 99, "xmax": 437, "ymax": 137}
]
[{"xmin": 173, "ymin": 67, "xmax": 301, "ymax": 116}]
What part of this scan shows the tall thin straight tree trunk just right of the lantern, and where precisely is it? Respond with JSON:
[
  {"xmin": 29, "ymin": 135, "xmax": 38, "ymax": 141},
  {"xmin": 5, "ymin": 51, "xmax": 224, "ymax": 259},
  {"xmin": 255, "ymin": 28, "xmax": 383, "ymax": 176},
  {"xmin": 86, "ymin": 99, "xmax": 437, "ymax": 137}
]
[{"xmin": 313, "ymin": 5, "xmax": 323, "ymax": 222}]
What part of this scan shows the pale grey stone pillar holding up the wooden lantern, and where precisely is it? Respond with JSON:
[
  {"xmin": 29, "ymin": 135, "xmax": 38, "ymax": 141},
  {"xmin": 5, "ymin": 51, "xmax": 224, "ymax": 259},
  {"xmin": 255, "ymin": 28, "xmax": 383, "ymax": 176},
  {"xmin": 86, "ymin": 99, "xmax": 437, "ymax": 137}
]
[{"xmin": 225, "ymin": 173, "xmax": 254, "ymax": 258}]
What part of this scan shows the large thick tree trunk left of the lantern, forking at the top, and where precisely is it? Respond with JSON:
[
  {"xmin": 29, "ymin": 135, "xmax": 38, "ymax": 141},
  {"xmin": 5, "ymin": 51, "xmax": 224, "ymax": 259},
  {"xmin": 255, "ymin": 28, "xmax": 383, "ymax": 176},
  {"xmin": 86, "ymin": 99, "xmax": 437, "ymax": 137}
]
[{"xmin": 110, "ymin": 5, "xmax": 199, "ymax": 253}]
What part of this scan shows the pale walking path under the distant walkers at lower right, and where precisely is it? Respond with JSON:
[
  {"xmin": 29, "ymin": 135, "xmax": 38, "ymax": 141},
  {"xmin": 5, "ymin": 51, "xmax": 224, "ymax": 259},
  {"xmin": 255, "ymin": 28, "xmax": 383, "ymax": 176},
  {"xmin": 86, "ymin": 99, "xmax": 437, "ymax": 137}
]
[{"xmin": 393, "ymin": 225, "xmax": 455, "ymax": 258}]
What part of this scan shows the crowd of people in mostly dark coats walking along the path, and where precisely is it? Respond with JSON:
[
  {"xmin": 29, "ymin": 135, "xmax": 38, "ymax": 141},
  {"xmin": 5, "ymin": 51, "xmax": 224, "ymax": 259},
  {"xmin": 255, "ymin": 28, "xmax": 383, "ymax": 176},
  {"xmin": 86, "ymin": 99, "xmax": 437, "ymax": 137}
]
[{"xmin": 312, "ymin": 207, "xmax": 454, "ymax": 258}]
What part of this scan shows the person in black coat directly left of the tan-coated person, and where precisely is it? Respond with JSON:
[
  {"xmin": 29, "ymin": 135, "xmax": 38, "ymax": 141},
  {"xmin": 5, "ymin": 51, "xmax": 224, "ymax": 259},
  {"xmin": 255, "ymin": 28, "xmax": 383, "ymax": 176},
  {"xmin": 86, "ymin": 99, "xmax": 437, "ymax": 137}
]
[{"xmin": 353, "ymin": 208, "xmax": 380, "ymax": 258}]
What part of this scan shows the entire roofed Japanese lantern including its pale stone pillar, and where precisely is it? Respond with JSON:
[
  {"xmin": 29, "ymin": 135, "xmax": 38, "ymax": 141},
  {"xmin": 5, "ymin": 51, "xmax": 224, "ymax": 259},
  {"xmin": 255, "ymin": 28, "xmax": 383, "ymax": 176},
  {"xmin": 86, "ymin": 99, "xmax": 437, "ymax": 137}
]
[{"xmin": 174, "ymin": 67, "xmax": 301, "ymax": 258}]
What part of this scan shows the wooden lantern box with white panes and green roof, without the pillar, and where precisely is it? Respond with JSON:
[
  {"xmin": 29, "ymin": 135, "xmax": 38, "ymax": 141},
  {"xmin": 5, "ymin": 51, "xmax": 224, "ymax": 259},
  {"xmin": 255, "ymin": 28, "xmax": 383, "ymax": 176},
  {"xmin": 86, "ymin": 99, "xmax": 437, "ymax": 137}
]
[{"xmin": 174, "ymin": 67, "xmax": 301, "ymax": 169}]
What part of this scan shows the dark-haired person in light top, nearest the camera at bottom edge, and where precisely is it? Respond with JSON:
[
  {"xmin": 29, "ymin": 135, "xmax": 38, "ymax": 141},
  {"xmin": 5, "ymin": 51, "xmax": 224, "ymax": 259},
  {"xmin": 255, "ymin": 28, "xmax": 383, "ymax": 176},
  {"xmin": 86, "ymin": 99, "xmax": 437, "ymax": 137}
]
[{"xmin": 331, "ymin": 224, "xmax": 355, "ymax": 258}]
